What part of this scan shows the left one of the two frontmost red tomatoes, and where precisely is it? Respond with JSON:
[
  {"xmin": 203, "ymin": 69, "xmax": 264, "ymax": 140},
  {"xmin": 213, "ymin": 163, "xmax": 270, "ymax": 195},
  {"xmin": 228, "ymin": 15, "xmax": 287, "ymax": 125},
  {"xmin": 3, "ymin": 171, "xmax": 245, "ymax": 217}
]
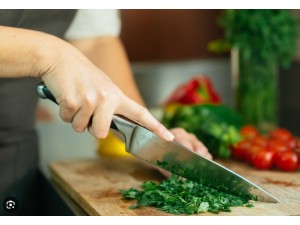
[{"xmin": 252, "ymin": 150, "xmax": 275, "ymax": 170}]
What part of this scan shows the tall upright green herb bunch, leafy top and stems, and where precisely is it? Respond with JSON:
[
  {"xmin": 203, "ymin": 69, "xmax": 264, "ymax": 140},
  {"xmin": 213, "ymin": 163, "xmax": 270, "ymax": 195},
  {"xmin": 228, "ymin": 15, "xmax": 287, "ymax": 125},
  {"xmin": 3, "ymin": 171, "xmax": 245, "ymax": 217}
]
[{"xmin": 209, "ymin": 9, "xmax": 297, "ymax": 132}]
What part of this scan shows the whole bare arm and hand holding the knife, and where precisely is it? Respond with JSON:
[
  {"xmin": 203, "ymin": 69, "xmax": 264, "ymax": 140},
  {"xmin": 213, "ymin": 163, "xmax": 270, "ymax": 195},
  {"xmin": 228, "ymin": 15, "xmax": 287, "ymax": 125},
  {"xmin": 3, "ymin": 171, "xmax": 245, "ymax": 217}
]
[{"xmin": 0, "ymin": 26, "xmax": 173, "ymax": 140}]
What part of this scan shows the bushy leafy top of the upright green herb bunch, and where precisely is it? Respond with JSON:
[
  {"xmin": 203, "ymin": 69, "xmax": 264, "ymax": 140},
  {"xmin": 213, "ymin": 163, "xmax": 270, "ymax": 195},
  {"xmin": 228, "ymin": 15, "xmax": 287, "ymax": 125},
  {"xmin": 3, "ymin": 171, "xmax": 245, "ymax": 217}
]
[{"xmin": 209, "ymin": 9, "xmax": 297, "ymax": 68}]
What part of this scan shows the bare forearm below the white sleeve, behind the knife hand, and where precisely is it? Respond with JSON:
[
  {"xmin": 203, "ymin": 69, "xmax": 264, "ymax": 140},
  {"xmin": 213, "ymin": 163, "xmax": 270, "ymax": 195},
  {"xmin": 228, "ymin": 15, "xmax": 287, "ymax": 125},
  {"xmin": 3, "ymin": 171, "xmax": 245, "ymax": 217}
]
[{"xmin": 70, "ymin": 37, "xmax": 144, "ymax": 105}]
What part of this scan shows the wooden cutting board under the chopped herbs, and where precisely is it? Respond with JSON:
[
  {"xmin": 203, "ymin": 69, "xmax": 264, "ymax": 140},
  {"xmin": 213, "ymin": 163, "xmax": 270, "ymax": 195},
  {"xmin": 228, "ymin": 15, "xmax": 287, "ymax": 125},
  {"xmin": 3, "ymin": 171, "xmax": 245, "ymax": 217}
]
[{"xmin": 50, "ymin": 158, "xmax": 300, "ymax": 216}]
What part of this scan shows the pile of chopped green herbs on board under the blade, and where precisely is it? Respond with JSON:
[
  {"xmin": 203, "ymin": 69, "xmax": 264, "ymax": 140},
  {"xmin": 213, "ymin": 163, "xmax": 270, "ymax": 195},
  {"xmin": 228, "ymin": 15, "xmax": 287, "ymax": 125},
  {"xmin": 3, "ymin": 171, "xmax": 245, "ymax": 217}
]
[{"xmin": 121, "ymin": 175, "xmax": 253, "ymax": 215}]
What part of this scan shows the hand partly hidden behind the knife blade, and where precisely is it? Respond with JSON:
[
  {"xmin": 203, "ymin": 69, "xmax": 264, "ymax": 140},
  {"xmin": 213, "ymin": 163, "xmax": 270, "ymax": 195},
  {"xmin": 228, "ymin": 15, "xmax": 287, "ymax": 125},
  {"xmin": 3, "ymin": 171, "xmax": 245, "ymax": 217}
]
[{"xmin": 158, "ymin": 128, "xmax": 212, "ymax": 177}]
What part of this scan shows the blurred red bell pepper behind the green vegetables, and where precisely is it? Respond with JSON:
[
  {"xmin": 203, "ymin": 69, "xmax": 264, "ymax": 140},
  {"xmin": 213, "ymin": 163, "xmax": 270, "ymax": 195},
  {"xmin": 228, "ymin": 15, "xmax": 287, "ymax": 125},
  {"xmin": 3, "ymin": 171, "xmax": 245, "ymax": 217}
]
[{"xmin": 165, "ymin": 76, "xmax": 220, "ymax": 105}]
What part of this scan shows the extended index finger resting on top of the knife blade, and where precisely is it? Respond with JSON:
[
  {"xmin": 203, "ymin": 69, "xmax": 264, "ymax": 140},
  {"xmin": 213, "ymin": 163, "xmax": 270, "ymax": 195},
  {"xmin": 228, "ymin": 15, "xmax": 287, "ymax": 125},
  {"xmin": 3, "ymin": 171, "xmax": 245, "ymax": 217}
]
[{"xmin": 117, "ymin": 97, "xmax": 174, "ymax": 141}]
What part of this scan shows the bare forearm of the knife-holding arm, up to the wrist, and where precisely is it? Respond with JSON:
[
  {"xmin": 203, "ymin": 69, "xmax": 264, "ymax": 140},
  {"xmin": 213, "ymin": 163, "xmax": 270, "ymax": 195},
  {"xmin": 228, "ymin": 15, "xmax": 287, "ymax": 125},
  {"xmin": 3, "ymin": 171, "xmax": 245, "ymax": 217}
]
[{"xmin": 0, "ymin": 26, "xmax": 60, "ymax": 78}]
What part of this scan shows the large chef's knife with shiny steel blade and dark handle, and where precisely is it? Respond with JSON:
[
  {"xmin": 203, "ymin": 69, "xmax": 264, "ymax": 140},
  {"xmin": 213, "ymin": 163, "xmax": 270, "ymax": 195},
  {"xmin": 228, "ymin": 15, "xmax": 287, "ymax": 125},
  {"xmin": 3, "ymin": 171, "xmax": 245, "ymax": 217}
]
[{"xmin": 37, "ymin": 83, "xmax": 279, "ymax": 203}]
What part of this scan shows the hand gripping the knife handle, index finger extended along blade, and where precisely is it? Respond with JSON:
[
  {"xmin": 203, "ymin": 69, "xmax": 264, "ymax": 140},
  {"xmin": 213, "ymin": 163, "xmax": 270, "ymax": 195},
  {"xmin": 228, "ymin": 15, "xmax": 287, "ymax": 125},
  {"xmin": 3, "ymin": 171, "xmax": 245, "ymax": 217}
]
[{"xmin": 40, "ymin": 38, "xmax": 174, "ymax": 141}]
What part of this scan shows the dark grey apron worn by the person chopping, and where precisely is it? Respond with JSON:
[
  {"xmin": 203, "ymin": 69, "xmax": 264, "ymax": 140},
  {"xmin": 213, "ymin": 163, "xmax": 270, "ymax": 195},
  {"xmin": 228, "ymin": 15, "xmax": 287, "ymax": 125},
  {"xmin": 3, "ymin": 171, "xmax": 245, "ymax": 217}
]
[{"xmin": 0, "ymin": 9, "xmax": 76, "ymax": 215}]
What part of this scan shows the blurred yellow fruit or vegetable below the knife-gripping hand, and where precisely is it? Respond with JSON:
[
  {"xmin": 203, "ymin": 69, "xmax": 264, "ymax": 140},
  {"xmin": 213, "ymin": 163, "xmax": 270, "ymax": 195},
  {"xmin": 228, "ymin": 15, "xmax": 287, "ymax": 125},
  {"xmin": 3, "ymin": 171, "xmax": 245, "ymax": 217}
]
[{"xmin": 97, "ymin": 131, "xmax": 131, "ymax": 158}]
